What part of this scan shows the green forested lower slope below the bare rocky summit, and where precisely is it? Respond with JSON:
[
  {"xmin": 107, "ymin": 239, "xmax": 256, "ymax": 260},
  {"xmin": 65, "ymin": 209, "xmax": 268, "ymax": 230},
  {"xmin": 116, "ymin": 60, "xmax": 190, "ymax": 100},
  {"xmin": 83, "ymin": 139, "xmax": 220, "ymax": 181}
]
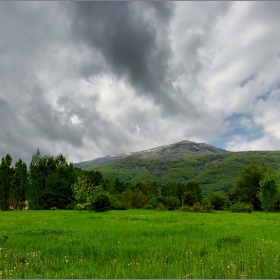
[{"xmin": 87, "ymin": 151, "xmax": 280, "ymax": 194}]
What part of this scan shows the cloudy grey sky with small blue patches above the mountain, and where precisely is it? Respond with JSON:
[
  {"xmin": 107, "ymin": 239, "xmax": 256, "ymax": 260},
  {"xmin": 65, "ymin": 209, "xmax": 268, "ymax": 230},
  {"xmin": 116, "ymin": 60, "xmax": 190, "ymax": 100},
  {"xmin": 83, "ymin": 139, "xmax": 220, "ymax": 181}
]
[{"xmin": 0, "ymin": 1, "xmax": 280, "ymax": 164}]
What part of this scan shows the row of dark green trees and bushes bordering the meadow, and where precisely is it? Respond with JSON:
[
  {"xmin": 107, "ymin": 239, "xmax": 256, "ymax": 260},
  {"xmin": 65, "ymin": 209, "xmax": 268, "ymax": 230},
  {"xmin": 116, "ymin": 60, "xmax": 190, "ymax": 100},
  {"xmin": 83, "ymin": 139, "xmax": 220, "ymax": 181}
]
[{"xmin": 0, "ymin": 149, "xmax": 280, "ymax": 212}]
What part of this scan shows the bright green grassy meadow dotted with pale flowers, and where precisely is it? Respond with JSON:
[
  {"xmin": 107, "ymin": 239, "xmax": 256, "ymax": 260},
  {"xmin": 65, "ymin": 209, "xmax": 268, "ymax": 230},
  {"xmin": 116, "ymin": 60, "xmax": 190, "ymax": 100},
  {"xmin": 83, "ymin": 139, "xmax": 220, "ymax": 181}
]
[{"xmin": 0, "ymin": 210, "xmax": 280, "ymax": 279}]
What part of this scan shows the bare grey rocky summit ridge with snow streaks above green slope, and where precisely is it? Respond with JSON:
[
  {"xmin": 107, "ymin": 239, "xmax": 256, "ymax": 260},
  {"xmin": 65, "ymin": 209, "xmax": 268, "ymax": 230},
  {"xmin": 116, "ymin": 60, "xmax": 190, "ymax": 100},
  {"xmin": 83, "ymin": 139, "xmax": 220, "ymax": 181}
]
[{"xmin": 74, "ymin": 140, "xmax": 227, "ymax": 169}]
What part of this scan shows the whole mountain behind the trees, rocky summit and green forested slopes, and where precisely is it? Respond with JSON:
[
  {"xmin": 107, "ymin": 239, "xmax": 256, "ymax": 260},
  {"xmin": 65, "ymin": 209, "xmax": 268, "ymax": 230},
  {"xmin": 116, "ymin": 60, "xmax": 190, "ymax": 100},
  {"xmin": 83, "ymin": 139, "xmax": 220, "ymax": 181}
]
[{"xmin": 75, "ymin": 140, "xmax": 280, "ymax": 195}]
